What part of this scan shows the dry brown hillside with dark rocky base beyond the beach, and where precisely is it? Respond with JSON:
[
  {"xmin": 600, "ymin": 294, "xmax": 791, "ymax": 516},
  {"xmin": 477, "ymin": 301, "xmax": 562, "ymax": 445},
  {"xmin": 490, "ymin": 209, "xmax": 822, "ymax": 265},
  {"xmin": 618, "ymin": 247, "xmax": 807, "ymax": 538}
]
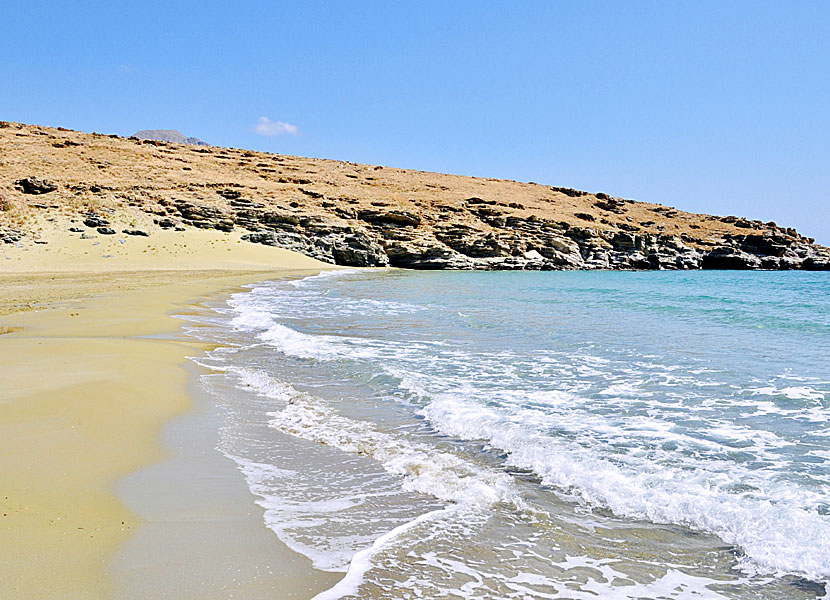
[{"xmin": 0, "ymin": 122, "xmax": 830, "ymax": 270}]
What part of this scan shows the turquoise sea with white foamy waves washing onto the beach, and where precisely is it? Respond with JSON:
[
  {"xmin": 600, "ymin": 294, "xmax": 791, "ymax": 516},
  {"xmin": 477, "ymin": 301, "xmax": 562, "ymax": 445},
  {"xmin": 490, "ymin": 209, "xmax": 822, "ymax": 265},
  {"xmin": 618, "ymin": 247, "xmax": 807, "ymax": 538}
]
[{"xmin": 183, "ymin": 269, "xmax": 830, "ymax": 600}]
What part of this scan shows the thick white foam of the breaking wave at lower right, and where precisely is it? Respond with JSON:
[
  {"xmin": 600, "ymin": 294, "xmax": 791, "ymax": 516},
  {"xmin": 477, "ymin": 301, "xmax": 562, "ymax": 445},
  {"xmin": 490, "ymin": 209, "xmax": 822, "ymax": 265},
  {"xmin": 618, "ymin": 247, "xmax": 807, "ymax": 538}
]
[{"xmin": 422, "ymin": 394, "xmax": 830, "ymax": 580}]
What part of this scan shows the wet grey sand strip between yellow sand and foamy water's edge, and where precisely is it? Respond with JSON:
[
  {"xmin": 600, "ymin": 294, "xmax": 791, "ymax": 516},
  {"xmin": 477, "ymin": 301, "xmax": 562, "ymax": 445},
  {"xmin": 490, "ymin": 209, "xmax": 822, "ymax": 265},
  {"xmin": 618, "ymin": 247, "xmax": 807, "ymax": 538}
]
[{"xmin": 114, "ymin": 346, "xmax": 343, "ymax": 600}]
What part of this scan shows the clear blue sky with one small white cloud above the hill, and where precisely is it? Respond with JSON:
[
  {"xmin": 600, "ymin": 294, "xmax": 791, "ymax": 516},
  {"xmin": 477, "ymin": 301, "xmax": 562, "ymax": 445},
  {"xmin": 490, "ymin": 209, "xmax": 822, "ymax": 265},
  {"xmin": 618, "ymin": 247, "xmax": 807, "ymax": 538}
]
[{"xmin": 0, "ymin": 0, "xmax": 830, "ymax": 244}]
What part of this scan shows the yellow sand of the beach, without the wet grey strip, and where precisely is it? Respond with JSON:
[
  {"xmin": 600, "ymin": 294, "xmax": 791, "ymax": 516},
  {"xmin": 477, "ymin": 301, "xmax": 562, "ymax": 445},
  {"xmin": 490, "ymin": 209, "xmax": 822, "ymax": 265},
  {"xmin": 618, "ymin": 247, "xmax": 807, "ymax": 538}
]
[{"xmin": 0, "ymin": 227, "xmax": 344, "ymax": 598}]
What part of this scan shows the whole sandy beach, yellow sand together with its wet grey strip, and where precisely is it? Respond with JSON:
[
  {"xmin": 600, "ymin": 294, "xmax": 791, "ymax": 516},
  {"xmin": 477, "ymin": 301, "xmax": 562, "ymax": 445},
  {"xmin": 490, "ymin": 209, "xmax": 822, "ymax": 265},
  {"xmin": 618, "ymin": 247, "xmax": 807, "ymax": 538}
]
[{"xmin": 0, "ymin": 223, "xmax": 342, "ymax": 598}]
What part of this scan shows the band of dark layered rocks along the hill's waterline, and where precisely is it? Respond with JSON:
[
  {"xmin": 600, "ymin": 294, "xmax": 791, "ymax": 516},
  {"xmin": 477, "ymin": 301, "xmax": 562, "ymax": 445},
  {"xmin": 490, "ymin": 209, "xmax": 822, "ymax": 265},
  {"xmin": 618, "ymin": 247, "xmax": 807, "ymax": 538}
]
[{"xmin": 145, "ymin": 197, "xmax": 830, "ymax": 270}]
